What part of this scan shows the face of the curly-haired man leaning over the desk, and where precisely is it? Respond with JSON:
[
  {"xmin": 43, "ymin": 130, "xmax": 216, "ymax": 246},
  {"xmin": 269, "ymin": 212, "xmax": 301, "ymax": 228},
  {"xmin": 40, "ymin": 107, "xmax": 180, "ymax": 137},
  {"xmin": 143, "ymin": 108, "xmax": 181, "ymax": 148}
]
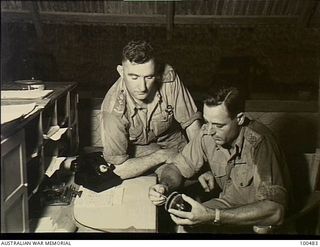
[{"xmin": 122, "ymin": 59, "xmax": 155, "ymax": 102}]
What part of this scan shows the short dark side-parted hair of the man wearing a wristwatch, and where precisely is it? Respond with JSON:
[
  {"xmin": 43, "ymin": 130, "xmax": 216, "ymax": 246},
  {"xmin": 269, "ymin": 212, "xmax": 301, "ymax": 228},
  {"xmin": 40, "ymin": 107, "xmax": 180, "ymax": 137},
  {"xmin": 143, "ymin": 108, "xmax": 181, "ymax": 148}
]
[{"xmin": 204, "ymin": 87, "xmax": 245, "ymax": 118}]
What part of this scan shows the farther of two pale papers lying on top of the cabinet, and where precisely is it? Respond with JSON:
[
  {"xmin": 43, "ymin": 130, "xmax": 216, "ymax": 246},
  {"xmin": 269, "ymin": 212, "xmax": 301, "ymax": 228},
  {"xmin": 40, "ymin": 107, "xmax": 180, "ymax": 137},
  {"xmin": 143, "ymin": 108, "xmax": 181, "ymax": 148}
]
[{"xmin": 1, "ymin": 90, "xmax": 53, "ymax": 99}]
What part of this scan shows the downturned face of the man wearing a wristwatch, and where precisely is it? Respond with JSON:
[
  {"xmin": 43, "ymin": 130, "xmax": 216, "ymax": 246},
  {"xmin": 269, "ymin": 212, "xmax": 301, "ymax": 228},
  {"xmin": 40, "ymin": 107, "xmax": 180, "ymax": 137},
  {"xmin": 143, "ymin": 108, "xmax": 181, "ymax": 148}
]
[{"xmin": 203, "ymin": 104, "xmax": 240, "ymax": 146}]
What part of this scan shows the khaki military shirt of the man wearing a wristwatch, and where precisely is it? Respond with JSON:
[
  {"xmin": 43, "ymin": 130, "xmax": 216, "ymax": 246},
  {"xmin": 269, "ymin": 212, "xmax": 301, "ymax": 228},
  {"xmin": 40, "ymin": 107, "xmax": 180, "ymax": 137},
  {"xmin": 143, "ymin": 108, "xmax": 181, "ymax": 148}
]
[{"xmin": 176, "ymin": 118, "xmax": 289, "ymax": 206}]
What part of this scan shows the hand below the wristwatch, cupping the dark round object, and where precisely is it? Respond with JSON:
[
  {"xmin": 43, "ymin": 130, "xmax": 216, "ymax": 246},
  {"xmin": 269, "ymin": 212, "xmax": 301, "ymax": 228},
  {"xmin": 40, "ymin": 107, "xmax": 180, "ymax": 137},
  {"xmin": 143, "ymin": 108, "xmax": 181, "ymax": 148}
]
[{"xmin": 168, "ymin": 195, "xmax": 215, "ymax": 225}]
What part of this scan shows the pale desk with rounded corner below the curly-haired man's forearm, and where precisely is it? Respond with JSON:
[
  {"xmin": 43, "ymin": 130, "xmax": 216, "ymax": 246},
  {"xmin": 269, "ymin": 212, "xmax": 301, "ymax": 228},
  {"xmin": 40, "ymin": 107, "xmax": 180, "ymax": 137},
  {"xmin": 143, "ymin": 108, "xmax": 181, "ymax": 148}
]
[{"xmin": 73, "ymin": 176, "xmax": 157, "ymax": 232}]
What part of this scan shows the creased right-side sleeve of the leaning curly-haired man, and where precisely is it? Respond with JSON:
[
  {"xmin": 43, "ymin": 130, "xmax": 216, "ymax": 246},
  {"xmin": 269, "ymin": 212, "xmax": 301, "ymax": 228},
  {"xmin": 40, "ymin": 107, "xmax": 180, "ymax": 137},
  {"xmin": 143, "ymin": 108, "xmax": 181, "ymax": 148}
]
[{"xmin": 172, "ymin": 74, "xmax": 202, "ymax": 129}]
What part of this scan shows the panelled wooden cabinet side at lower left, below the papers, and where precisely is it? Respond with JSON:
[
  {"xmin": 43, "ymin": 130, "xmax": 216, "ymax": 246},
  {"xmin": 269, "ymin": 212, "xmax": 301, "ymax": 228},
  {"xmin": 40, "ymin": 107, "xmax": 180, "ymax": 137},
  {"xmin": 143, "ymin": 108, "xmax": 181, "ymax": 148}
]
[{"xmin": 1, "ymin": 130, "xmax": 29, "ymax": 232}]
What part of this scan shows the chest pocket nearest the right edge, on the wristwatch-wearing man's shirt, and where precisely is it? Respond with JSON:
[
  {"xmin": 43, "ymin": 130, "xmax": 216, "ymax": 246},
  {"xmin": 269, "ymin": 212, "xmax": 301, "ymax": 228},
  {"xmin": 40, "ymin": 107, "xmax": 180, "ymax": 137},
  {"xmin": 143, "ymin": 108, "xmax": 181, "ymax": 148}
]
[{"xmin": 230, "ymin": 164, "xmax": 253, "ymax": 188}]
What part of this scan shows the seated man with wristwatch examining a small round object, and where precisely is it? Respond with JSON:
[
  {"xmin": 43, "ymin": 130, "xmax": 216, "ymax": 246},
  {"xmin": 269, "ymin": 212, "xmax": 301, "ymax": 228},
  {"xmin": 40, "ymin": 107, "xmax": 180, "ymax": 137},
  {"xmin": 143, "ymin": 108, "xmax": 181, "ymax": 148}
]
[{"xmin": 149, "ymin": 87, "xmax": 289, "ymax": 233}]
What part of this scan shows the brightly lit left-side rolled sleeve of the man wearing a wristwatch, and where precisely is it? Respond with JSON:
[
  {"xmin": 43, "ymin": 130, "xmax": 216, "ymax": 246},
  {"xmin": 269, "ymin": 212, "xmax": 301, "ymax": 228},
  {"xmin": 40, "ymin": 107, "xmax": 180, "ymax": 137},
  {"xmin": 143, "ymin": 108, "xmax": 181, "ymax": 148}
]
[{"xmin": 175, "ymin": 134, "xmax": 207, "ymax": 178}]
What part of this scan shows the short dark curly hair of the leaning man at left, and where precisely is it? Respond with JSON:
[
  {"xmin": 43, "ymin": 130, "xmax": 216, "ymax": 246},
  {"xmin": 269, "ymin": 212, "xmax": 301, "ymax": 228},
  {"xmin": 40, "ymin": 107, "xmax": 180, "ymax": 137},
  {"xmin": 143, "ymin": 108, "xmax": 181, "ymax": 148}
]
[{"xmin": 122, "ymin": 40, "xmax": 155, "ymax": 64}]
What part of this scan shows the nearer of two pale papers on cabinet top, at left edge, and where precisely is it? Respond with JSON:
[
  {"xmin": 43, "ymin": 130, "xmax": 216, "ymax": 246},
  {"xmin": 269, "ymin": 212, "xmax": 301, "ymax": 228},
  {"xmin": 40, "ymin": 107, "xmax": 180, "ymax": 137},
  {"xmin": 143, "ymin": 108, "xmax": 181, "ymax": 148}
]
[{"xmin": 1, "ymin": 103, "xmax": 36, "ymax": 124}]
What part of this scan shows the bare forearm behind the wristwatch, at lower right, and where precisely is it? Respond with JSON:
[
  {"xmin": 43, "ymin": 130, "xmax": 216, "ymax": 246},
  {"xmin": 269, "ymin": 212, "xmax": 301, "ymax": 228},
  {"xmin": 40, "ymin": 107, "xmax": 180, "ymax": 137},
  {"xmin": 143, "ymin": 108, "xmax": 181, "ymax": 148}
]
[{"xmin": 218, "ymin": 201, "xmax": 284, "ymax": 225}]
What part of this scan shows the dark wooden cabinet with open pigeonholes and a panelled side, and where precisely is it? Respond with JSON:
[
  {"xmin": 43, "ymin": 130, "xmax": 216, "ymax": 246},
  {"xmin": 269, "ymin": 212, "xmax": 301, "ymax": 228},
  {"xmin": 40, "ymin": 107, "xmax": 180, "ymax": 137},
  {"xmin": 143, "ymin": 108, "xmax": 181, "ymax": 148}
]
[{"xmin": 1, "ymin": 82, "xmax": 79, "ymax": 232}]
